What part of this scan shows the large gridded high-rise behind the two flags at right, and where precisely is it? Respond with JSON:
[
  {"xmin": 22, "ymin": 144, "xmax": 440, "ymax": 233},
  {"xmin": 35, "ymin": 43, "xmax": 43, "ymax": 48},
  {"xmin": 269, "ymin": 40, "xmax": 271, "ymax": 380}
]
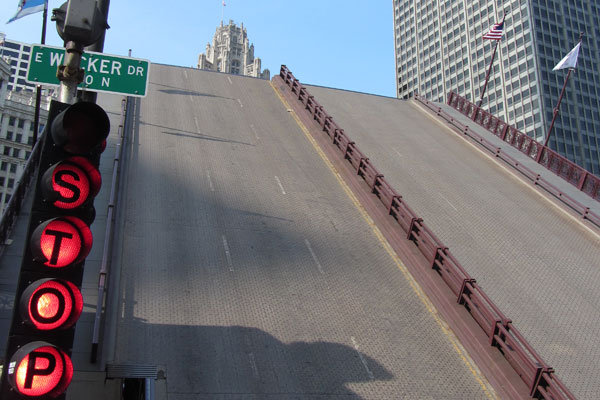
[{"xmin": 393, "ymin": 0, "xmax": 600, "ymax": 175}]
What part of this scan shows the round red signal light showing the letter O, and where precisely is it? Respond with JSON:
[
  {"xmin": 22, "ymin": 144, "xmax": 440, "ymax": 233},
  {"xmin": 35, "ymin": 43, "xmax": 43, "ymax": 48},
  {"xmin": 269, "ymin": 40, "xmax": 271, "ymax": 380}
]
[{"xmin": 19, "ymin": 278, "xmax": 83, "ymax": 331}]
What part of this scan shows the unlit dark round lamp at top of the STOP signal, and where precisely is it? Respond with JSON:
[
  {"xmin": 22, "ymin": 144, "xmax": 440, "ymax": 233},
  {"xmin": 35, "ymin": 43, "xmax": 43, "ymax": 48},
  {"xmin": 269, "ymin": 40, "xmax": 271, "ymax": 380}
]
[{"xmin": 50, "ymin": 101, "xmax": 110, "ymax": 154}]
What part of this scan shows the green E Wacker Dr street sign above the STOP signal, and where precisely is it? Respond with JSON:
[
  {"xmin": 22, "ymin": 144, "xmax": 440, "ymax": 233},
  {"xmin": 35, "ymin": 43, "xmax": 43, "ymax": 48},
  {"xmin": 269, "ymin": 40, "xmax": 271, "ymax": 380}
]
[{"xmin": 26, "ymin": 44, "xmax": 150, "ymax": 97}]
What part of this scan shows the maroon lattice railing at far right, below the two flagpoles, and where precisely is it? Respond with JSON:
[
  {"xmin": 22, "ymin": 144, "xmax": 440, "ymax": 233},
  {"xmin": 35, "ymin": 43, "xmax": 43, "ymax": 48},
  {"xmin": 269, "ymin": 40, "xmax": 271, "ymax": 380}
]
[{"xmin": 448, "ymin": 92, "xmax": 600, "ymax": 201}]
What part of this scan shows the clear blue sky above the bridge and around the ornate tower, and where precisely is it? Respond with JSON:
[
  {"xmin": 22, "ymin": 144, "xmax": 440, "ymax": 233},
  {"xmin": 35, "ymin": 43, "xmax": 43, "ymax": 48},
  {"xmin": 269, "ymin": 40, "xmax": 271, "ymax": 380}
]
[{"xmin": 0, "ymin": 0, "xmax": 396, "ymax": 97}]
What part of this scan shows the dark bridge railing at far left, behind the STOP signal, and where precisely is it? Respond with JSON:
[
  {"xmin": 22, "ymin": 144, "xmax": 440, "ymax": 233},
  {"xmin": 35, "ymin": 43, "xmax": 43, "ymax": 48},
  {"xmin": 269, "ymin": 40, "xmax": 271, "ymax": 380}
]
[{"xmin": 0, "ymin": 131, "xmax": 44, "ymax": 251}]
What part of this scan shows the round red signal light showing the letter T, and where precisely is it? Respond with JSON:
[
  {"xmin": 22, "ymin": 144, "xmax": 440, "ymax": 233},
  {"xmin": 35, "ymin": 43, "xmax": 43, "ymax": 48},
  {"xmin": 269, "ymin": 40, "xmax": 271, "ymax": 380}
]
[{"xmin": 29, "ymin": 216, "xmax": 92, "ymax": 268}]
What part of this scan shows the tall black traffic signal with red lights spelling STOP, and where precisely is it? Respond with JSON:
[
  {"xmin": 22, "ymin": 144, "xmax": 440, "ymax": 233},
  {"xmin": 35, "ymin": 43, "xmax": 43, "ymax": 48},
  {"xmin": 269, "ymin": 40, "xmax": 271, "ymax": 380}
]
[{"xmin": 0, "ymin": 101, "xmax": 110, "ymax": 400}]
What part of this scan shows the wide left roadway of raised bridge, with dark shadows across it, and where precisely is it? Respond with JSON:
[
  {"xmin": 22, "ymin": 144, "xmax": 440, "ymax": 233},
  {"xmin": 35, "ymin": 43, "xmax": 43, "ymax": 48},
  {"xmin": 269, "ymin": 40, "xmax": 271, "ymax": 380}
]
[{"xmin": 104, "ymin": 65, "xmax": 495, "ymax": 400}]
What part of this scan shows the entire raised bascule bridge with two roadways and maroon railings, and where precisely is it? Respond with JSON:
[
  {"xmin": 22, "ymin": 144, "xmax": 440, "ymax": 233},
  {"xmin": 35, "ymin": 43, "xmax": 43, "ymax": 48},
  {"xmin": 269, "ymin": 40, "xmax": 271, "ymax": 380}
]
[{"xmin": 0, "ymin": 64, "xmax": 600, "ymax": 400}]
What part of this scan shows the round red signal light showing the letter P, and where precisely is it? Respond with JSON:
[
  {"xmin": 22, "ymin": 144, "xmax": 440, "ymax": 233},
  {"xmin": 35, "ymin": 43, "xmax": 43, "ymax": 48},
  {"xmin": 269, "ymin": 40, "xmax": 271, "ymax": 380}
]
[{"xmin": 8, "ymin": 342, "xmax": 73, "ymax": 398}]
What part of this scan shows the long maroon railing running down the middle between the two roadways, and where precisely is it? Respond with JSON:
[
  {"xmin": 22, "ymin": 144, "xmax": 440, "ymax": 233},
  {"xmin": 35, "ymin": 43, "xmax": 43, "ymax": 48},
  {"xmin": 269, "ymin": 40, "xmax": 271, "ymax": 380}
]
[{"xmin": 280, "ymin": 65, "xmax": 575, "ymax": 399}]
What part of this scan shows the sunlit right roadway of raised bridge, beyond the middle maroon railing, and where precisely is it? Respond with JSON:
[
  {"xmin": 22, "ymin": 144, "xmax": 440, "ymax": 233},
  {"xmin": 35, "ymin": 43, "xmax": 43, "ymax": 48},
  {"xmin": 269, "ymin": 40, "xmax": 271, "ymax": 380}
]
[{"xmin": 307, "ymin": 83, "xmax": 600, "ymax": 399}]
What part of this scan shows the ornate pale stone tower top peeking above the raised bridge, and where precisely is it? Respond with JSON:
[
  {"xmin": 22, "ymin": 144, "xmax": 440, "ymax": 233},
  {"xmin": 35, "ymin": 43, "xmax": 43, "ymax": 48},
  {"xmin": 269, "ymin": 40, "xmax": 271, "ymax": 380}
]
[{"xmin": 198, "ymin": 21, "xmax": 270, "ymax": 79}]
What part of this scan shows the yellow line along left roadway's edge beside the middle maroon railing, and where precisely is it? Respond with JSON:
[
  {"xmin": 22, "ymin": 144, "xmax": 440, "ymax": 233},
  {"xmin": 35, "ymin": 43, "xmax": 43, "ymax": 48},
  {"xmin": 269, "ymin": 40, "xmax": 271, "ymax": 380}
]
[{"xmin": 271, "ymin": 82, "xmax": 498, "ymax": 399}]
